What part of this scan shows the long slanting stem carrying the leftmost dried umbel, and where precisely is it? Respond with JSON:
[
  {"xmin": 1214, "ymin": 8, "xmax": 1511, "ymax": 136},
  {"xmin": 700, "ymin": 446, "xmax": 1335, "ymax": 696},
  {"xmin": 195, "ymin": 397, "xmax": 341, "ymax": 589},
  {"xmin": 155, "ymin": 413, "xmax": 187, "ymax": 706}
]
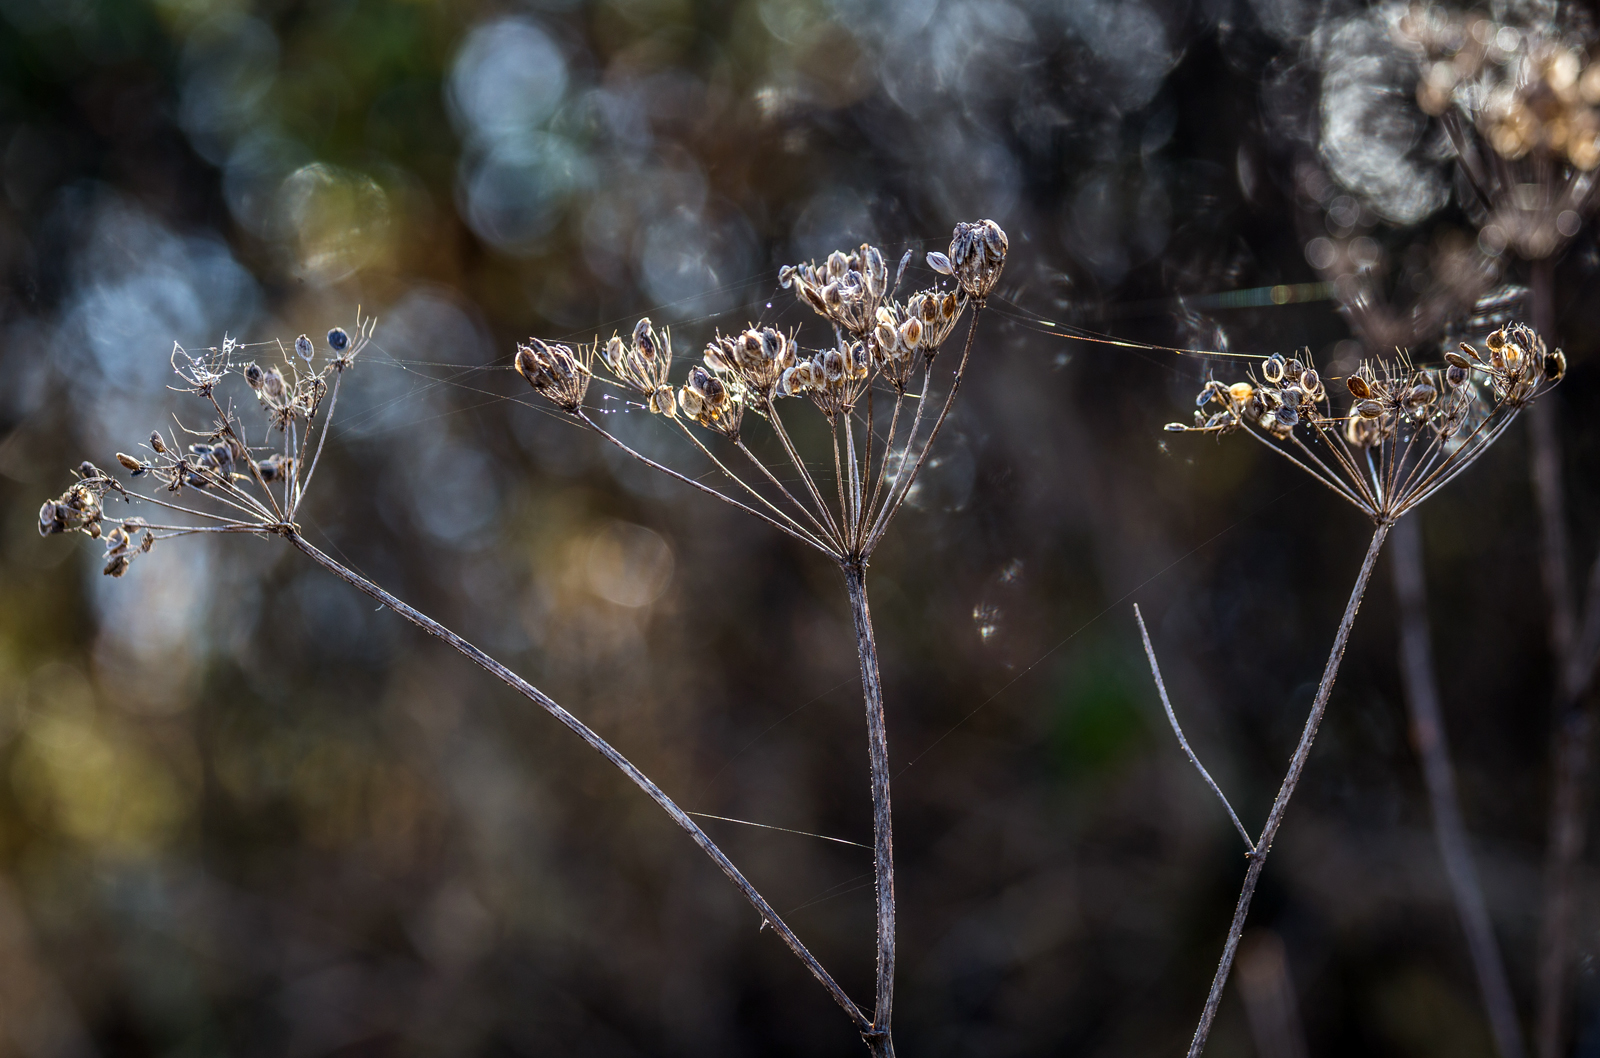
[{"xmin": 283, "ymin": 528, "xmax": 872, "ymax": 1034}]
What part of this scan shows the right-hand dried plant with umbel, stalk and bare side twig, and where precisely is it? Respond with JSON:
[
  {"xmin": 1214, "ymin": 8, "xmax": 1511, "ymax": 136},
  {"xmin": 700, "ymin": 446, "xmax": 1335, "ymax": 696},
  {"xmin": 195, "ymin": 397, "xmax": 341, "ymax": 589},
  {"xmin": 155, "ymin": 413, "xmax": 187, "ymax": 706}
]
[{"xmin": 1134, "ymin": 323, "xmax": 1566, "ymax": 1058}]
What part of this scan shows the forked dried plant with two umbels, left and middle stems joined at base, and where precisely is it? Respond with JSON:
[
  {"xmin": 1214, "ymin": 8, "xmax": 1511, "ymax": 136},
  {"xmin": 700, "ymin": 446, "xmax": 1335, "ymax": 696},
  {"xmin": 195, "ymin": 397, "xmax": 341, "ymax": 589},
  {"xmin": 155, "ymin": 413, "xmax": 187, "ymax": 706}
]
[{"xmin": 38, "ymin": 221, "xmax": 1006, "ymax": 1056}]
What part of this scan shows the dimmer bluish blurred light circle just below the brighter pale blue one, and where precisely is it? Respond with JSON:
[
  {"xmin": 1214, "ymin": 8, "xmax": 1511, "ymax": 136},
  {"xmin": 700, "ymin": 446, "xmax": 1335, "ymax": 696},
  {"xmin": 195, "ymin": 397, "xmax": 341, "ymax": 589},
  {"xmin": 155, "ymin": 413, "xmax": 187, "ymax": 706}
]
[{"xmin": 461, "ymin": 133, "xmax": 589, "ymax": 253}]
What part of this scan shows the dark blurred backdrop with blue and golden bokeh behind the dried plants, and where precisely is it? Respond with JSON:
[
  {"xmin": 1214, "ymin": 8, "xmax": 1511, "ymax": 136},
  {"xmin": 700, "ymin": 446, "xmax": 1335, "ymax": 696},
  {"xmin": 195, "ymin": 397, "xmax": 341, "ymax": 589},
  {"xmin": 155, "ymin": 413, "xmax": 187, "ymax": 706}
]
[{"xmin": 0, "ymin": 0, "xmax": 1600, "ymax": 1058}]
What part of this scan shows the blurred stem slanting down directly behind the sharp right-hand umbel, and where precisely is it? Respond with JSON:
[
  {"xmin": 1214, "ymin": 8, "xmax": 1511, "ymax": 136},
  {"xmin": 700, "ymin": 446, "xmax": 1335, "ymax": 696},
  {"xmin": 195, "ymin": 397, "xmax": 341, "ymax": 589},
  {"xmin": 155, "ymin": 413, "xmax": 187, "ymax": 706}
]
[{"xmin": 1389, "ymin": 519, "xmax": 1525, "ymax": 1058}]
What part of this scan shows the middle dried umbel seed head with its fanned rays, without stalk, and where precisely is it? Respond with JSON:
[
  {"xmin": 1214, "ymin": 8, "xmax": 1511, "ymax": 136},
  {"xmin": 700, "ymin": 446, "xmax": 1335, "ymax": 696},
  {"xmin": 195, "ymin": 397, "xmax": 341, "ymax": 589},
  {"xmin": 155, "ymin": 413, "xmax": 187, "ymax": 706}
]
[{"xmin": 517, "ymin": 221, "xmax": 1008, "ymax": 562}]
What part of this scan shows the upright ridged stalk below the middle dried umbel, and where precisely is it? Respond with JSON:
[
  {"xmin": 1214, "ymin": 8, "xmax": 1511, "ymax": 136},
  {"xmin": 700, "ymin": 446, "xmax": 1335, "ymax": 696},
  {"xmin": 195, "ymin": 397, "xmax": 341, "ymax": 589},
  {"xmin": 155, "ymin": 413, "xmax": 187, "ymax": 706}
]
[{"xmin": 843, "ymin": 562, "xmax": 894, "ymax": 1058}]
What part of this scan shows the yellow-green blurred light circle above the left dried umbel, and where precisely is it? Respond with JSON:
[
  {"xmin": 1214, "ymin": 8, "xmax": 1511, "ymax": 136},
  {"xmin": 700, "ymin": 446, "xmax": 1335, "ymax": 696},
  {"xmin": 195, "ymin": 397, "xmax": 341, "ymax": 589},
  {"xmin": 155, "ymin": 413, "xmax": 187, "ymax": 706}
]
[{"xmin": 278, "ymin": 162, "xmax": 389, "ymax": 283}]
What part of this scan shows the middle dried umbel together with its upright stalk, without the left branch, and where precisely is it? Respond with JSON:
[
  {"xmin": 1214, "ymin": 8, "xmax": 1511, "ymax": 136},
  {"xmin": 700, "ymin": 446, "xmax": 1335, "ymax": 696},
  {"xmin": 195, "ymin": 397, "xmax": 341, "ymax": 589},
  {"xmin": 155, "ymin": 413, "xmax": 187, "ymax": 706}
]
[{"xmin": 517, "ymin": 221, "xmax": 1008, "ymax": 1055}]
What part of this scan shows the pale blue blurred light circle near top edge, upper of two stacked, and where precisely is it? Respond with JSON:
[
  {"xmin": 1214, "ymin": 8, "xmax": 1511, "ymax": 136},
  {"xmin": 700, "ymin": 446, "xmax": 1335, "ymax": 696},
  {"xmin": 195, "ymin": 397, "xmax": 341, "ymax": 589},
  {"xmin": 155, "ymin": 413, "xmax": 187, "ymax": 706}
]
[{"xmin": 446, "ymin": 18, "xmax": 566, "ymax": 144}]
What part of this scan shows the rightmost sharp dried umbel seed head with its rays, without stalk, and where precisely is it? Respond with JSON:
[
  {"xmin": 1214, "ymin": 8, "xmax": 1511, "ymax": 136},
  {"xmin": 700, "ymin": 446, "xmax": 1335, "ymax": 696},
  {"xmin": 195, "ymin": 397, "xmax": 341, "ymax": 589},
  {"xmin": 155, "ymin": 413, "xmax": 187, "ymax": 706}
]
[{"xmin": 1166, "ymin": 323, "xmax": 1565, "ymax": 522}]
